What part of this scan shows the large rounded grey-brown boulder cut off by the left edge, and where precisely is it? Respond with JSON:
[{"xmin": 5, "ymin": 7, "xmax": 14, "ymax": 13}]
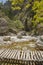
[{"xmin": 0, "ymin": 18, "xmax": 8, "ymax": 35}]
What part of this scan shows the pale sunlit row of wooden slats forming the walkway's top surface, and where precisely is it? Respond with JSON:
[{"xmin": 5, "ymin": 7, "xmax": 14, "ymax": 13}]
[{"xmin": 0, "ymin": 49, "xmax": 43, "ymax": 61}]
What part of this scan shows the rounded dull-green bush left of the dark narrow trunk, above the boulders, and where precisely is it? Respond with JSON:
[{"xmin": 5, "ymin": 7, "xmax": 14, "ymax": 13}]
[{"xmin": 9, "ymin": 20, "xmax": 24, "ymax": 29}]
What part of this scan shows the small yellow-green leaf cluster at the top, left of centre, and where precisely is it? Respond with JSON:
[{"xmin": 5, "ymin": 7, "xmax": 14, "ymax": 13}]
[{"xmin": 10, "ymin": 0, "xmax": 24, "ymax": 10}]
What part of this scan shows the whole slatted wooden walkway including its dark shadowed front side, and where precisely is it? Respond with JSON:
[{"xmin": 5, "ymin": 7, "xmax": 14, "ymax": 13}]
[{"xmin": 0, "ymin": 49, "xmax": 43, "ymax": 65}]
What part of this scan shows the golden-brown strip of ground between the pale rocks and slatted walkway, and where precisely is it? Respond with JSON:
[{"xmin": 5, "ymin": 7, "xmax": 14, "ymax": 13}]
[{"xmin": 0, "ymin": 41, "xmax": 39, "ymax": 50}]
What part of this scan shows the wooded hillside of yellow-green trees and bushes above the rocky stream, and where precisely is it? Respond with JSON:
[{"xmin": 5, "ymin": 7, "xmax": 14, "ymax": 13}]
[{"xmin": 0, "ymin": 0, "xmax": 43, "ymax": 35}]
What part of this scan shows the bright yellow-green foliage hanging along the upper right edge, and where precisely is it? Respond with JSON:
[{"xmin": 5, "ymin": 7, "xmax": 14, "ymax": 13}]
[{"xmin": 32, "ymin": 0, "xmax": 43, "ymax": 25}]
